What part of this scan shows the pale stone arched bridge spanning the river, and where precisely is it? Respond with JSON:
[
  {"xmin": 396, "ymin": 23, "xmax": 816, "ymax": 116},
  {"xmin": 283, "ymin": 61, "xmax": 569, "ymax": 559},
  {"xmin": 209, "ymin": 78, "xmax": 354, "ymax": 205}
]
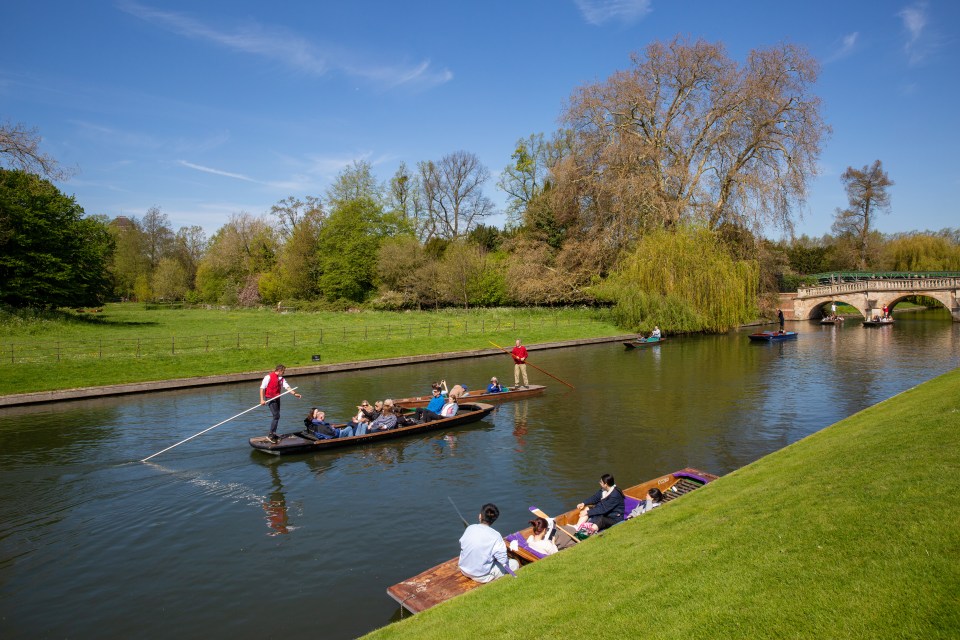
[{"xmin": 781, "ymin": 278, "xmax": 960, "ymax": 322}]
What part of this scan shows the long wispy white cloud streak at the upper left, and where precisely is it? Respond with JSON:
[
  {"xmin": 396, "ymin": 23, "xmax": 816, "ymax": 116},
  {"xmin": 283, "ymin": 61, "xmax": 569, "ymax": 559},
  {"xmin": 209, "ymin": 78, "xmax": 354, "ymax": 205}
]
[{"xmin": 117, "ymin": 1, "xmax": 453, "ymax": 88}]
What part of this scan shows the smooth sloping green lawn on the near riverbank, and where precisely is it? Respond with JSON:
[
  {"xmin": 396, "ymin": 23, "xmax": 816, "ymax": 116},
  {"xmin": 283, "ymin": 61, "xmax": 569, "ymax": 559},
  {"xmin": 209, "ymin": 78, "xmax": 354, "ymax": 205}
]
[{"xmin": 368, "ymin": 370, "xmax": 960, "ymax": 640}]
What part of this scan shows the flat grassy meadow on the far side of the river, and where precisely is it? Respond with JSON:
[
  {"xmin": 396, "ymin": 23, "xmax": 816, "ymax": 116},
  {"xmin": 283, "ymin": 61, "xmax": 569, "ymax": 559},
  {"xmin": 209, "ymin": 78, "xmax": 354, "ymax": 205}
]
[{"xmin": 0, "ymin": 303, "xmax": 622, "ymax": 395}]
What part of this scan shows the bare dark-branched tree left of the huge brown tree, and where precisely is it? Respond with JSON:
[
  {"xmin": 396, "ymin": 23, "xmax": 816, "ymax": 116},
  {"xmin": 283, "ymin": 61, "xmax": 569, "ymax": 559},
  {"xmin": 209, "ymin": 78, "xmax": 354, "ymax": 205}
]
[{"xmin": 418, "ymin": 151, "xmax": 494, "ymax": 240}]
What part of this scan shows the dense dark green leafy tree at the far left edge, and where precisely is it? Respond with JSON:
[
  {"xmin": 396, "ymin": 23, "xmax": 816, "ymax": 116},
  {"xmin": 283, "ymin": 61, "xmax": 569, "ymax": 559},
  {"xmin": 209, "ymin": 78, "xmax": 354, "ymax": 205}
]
[{"xmin": 0, "ymin": 169, "xmax": 113, "ymax": 309}]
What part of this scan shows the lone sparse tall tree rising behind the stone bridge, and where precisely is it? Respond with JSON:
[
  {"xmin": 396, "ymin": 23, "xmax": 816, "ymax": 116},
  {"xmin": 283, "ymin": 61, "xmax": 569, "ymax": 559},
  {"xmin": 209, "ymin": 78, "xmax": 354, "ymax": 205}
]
[{"xmin": 833, "ymin": 160, "xmax": 894, "ymax": 270}]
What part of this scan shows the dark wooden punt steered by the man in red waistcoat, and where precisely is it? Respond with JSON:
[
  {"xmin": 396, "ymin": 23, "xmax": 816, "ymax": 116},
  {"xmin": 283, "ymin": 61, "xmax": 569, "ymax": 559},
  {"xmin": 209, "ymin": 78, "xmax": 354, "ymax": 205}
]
[{"xmin": 250, "ymin": 402, "xmax": 494, "ymax": 456}]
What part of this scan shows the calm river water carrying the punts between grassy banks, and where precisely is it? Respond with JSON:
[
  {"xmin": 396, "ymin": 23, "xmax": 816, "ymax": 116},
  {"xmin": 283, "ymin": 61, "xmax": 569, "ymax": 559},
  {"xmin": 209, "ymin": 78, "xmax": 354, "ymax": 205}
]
[{"xmin": 0, "ymin": 309, "xmax": 960, "ymax": 639}]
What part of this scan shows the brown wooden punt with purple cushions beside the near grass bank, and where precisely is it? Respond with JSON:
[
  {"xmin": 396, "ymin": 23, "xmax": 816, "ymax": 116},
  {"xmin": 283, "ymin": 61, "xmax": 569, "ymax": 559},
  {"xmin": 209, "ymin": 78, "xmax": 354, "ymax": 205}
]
[{"xmin": 387, "ymin": 467, "xmax": 717, "ymax": 613}]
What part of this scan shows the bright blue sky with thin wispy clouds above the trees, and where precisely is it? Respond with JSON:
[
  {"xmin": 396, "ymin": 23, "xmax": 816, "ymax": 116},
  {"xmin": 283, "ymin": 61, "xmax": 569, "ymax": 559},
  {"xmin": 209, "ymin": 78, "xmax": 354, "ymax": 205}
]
[{"xmin": 0, "ymin": 0, "xmax": 960, "ymax": 237}]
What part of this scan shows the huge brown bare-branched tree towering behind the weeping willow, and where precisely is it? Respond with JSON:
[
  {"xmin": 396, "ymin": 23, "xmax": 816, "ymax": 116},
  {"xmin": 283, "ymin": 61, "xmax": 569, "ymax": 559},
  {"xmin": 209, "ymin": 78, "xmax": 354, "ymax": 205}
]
[{"xmin": 554, "ymin": 37, "xmax": 829, "ymax": 251}]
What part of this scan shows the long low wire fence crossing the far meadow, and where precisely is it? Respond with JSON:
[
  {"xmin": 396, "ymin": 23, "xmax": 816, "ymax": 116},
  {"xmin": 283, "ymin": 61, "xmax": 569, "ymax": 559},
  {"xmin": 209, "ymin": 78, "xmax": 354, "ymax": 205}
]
[{"xmin": 0, "ymin": 316, "xmax": 612, "ymax": 365}]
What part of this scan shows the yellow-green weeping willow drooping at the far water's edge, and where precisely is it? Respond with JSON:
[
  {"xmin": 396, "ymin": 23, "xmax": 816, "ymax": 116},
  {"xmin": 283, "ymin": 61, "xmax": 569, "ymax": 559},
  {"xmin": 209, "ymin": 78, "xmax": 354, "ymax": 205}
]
[{"xmin": 600, "ymin": 225, "xmax": 759, "ymax": 331}]
